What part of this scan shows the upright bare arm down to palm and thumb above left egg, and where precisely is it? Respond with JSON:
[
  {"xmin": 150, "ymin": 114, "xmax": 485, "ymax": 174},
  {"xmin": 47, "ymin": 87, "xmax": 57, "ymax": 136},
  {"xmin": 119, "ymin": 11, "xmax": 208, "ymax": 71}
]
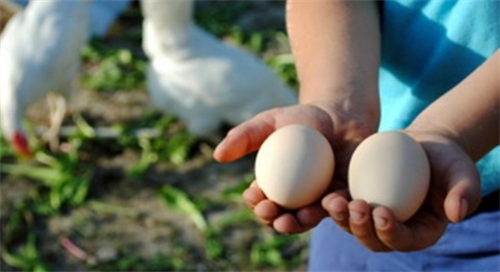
[{"xmin": 214, "ymin": 0, "xmax": 380, "ymax": 166}]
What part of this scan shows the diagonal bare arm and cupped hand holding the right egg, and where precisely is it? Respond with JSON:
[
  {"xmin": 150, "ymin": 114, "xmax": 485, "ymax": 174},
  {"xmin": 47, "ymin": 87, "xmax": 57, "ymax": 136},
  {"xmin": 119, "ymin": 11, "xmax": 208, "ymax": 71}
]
[{"xmin": 323, "ymin": 50, "xmax": 500, "ymax": 251}]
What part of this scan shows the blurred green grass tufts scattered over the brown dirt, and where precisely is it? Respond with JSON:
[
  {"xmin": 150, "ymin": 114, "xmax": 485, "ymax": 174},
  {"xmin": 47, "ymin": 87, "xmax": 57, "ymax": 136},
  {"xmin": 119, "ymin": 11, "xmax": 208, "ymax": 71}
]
[{"xmin": 0, "ymin": 1, "xmax": 307, "ymax": 272}]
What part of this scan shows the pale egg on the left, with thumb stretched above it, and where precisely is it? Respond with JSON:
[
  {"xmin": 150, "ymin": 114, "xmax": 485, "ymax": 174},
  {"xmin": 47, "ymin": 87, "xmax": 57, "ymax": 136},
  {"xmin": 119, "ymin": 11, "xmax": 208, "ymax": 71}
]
[{"xmin": 255, "ymin": 125, "xmax": 335, "ymax": 209}]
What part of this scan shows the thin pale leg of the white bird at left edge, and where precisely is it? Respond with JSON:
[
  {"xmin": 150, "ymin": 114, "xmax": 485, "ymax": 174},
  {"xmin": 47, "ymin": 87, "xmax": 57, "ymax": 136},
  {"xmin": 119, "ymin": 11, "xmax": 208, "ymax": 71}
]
[{"xmin": 43, "ymin": 93, "xmax": 66, "ymax": 151}]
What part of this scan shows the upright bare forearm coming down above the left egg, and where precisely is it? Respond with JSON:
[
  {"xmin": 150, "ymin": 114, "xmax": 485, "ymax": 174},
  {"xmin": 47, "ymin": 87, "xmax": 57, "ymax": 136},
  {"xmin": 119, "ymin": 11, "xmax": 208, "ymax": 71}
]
[{"xmin": 287, "ymin": 0, "xmax": 380, "ymax": 119}]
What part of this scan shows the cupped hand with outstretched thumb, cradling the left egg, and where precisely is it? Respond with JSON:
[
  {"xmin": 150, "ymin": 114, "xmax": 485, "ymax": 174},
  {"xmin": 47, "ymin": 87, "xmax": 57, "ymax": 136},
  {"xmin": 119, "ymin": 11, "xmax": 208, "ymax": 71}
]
[{"xmin": 213, "ymin": 104, "xmax": 375, "ymax": 234}]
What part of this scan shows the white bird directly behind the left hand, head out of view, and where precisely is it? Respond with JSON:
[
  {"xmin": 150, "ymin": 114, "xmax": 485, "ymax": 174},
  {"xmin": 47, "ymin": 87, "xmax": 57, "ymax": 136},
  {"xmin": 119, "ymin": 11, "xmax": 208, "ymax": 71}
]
[{"xmin": 140, "ymin": 0, "xmax": 297, "ymax": 136}]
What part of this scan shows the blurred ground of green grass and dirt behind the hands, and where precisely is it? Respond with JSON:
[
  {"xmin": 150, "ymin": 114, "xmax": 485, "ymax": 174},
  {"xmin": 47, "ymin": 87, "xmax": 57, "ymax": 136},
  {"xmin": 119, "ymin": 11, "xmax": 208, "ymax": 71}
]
[{"xmin": 0, "ymin": 0, "xmax": 308, "ymax": 272}]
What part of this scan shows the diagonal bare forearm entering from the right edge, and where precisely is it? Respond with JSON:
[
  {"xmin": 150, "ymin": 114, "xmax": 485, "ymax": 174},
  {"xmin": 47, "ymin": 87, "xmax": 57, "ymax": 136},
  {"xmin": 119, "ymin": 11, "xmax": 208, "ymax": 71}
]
[{"xmin": 409, "ymin": 50, "xmax": 500, "ymax": 161}]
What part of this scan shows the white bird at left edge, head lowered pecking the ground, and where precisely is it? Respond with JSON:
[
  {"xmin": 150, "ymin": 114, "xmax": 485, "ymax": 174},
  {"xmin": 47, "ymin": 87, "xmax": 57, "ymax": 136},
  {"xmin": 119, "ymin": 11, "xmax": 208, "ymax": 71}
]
[{"xmin": 0, "ymin": 0, "xmax": 92, "ymax": 155}]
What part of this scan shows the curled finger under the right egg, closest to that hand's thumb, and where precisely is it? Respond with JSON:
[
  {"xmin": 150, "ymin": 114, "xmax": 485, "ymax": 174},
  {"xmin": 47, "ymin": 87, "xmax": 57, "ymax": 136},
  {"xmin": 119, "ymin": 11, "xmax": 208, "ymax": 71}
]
[{"xmin": 372, "ymin": 204, "xmax": 446, "ymax": 252}]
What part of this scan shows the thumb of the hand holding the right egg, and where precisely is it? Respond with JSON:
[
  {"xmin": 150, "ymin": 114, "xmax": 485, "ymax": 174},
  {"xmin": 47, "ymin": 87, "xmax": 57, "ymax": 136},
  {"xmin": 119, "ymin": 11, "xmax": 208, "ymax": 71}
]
[{"xmin": 444, "ymin": 160, "xmax": 481, "ymax": 223}]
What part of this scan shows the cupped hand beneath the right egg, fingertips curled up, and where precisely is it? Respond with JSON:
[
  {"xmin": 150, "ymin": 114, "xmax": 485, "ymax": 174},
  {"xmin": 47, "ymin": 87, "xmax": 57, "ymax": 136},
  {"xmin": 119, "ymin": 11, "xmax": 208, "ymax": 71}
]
[{"xmin": 322, "ymin": 130, "xmax": 481, "ymax": 251}]
